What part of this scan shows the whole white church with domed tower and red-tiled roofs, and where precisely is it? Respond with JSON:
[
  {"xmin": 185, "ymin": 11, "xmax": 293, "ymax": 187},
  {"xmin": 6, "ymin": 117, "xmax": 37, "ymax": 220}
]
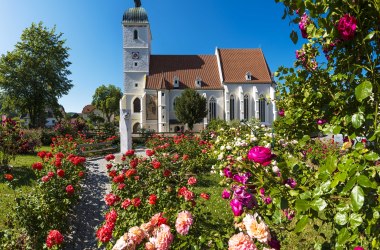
[{"xmin": 120, "ymin": 1, "xmax": 277, "ymax": 152}]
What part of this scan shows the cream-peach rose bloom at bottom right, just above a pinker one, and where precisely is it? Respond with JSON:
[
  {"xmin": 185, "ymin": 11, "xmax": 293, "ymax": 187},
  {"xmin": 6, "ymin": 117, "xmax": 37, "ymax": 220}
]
[{"xmin": 243, "ymin": 213, "xmax": 271, "ymax": 243}]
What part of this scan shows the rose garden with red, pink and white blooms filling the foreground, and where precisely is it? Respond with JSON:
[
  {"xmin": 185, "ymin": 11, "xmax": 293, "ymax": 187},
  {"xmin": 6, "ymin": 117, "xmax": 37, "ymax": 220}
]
[{"xmin": 0, "ymin": 0, "xmax": 380, "ymax": 250}]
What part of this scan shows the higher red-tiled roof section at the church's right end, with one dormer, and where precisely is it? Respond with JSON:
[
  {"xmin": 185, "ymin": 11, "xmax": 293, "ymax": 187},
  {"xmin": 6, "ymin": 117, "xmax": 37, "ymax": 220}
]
[{"xmin": 218, "ymin": 49, "xmax": 272, "ymax": 83}]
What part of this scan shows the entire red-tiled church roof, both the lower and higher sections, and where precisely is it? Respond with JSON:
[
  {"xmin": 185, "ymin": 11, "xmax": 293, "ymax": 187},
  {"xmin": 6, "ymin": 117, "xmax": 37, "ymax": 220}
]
[{"xmin": 145, "ymin": 49, "xmax": 272, "ymax": 89}]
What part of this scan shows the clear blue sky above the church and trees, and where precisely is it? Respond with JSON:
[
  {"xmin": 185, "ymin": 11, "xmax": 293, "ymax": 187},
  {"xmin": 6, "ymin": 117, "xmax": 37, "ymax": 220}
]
[{"xmin": 0, "ymin": 0, "xmax": 300, "ymax": 112}]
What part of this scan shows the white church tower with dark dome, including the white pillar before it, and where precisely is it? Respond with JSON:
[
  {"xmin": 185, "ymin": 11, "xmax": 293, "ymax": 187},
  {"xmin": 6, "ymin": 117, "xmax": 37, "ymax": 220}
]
[{"xmin": 119, "ymin": 0, "xmax": 152, "ymax": 153}]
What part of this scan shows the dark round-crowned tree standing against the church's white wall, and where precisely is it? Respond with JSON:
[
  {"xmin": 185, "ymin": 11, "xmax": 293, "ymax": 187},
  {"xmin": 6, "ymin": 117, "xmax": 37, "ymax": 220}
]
[{"xmin": 174, "ymin": 89, "xmax": 207, "ymax": 130}]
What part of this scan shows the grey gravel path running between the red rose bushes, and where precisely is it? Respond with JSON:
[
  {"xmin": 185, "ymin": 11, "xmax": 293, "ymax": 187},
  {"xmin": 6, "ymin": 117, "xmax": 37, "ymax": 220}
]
[{"xmin": 64, "ymin": 148, "xmax": 145, "ymax": 250}]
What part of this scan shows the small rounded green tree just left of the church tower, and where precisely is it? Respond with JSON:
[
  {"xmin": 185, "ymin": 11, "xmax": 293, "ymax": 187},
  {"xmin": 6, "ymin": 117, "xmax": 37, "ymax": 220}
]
[{"xmin": 92, "ymin": 84, "xmax": 123, "ymax": 122}]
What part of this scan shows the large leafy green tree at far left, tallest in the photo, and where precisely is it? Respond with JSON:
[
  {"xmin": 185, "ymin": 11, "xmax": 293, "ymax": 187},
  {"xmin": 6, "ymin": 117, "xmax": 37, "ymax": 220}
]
[{"xmin": 0, "ymin": 22, "xmax": 73, "ymax": 127}]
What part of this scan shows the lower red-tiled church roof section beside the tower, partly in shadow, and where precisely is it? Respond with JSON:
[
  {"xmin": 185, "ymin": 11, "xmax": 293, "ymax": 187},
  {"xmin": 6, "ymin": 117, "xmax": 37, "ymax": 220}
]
[{"xmin": 145, "ymin": 55, "xmax": 223, "ymax": 89}]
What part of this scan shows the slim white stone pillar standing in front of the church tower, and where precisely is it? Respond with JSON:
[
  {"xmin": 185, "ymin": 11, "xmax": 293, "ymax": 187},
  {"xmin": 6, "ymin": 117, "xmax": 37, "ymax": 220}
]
[{"xmin": 119, "ymin": 94, "xmax": 132, "ymax": 153}]
